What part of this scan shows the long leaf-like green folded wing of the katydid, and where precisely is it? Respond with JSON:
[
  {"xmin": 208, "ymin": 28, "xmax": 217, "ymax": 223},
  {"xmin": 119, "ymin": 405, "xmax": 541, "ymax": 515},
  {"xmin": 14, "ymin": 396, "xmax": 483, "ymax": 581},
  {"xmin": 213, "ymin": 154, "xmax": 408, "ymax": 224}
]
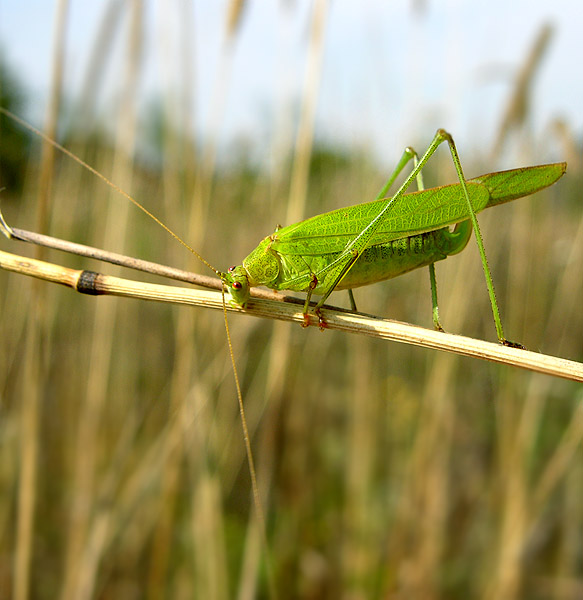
[{"xmin": 271, "ymin": 163, "xmax": 566, "ymax": 256}]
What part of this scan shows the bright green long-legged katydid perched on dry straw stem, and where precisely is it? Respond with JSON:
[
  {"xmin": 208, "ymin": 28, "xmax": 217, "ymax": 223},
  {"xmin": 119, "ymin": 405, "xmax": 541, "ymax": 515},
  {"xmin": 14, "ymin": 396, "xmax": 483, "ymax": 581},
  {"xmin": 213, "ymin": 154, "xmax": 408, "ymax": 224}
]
[{"xmin": 219, "ymin": 129, "xmax": 567, "ymax": 345}]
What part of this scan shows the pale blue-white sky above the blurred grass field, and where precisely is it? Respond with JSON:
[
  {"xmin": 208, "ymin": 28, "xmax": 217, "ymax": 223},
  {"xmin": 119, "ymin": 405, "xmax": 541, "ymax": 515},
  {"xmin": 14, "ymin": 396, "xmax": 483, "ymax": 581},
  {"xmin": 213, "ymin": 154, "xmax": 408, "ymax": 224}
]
[{"xmin": 0, "ymin": 0, "xmax": 583, "ymax": 170}]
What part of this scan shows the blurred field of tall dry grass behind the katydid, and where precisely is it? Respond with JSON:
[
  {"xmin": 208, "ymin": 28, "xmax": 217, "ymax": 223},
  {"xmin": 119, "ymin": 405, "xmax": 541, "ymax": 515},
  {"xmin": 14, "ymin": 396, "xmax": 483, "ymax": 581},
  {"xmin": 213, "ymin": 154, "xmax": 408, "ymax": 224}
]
[{"xmin": 0, "ymin": 1, "xmax": 583, "ymax": 600}]
